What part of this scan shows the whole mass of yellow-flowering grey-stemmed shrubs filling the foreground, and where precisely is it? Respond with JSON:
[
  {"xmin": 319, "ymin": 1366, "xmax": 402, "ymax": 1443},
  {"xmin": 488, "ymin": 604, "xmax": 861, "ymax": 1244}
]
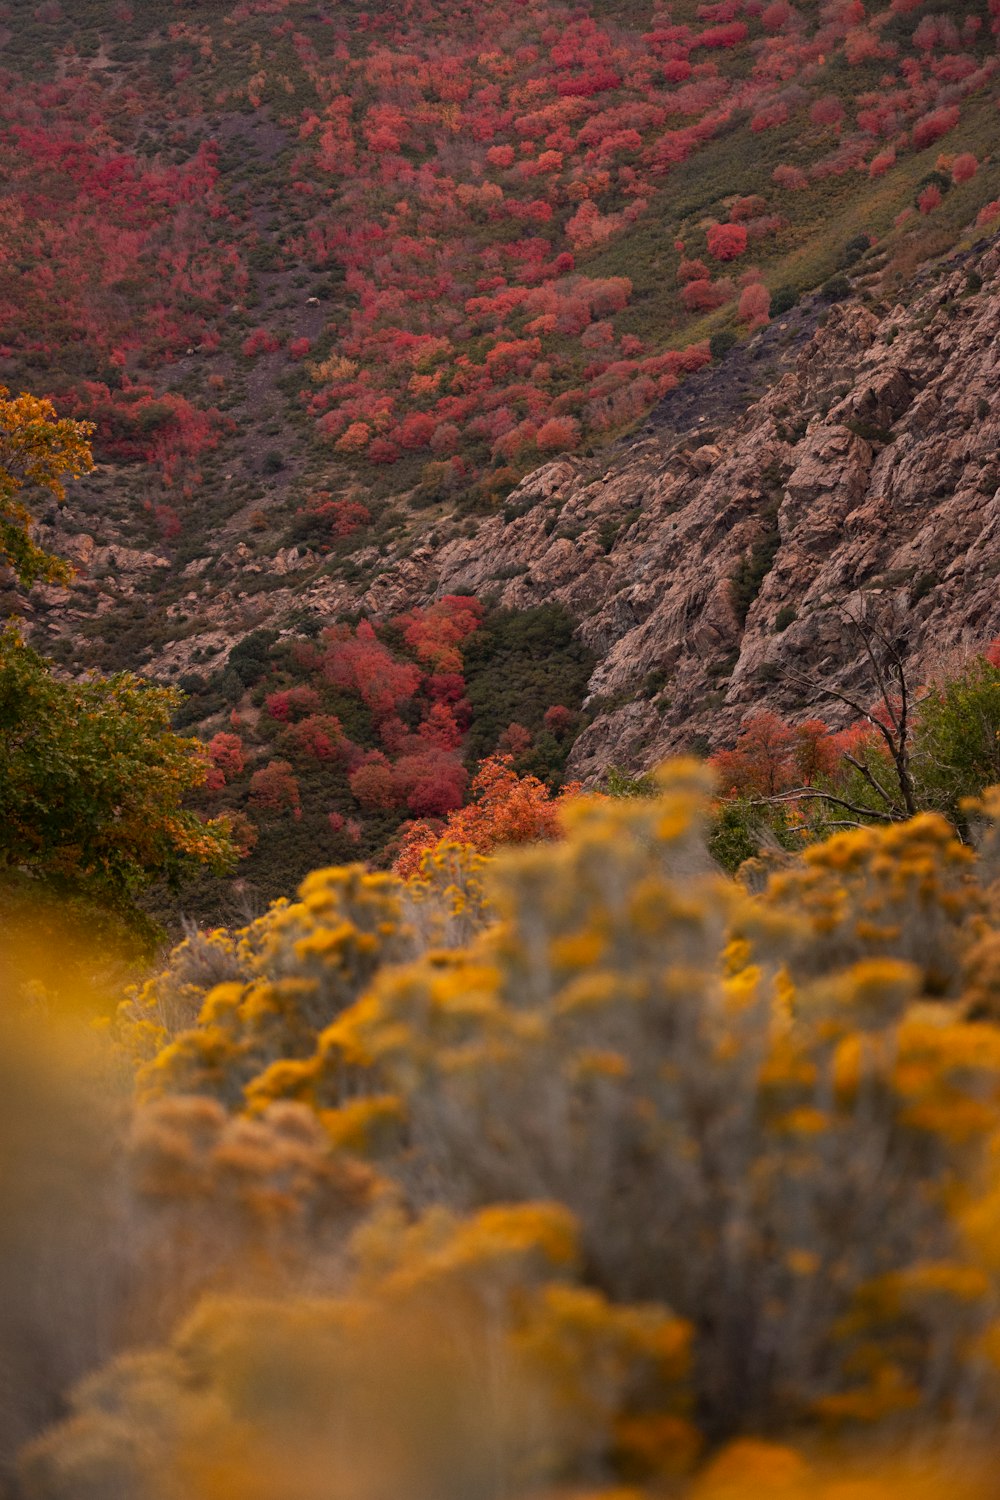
[{"xmin": 13, "ymin": 762, "xmax": 1000, "ymax": 1500}]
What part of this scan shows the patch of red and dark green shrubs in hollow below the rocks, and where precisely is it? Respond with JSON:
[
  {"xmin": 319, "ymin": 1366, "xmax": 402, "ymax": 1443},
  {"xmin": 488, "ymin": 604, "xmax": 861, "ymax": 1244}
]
[{"xmin": 167, "ymin": 594, "xmax": 591, "ymax": 918}]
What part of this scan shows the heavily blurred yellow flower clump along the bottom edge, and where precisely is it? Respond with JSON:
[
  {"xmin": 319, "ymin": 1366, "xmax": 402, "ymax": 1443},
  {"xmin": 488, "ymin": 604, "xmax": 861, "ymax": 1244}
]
[{"xmin": 21, "ymin": 1205, "xmax": 699, "ymax": 1500}]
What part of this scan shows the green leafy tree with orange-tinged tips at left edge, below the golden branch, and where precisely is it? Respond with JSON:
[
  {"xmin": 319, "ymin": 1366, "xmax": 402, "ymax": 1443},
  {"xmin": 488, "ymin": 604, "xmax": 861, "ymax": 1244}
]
[{"xmin": 0, "ymin": 626, "xmax": 232, "ymax": 915}]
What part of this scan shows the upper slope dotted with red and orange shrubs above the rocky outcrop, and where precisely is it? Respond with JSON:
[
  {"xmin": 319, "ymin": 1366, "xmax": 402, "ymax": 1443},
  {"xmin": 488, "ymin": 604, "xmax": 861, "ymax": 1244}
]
[{"xmin": 0, "ymin": 0, "xmax": 1000, "ymax": 564}]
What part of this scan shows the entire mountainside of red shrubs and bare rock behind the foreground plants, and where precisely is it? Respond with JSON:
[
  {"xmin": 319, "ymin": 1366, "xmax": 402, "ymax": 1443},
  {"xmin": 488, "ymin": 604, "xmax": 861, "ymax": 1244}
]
[{"xmin": 0, "ymin": 0, "xmax": 1000, "ymax": 894}]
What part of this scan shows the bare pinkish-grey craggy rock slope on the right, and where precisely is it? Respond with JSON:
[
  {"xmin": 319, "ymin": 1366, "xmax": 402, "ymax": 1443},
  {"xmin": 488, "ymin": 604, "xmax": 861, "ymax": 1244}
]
[{"xmin": 379, "ymin": 242, "xmax": 1000, "ymax": 777}]
